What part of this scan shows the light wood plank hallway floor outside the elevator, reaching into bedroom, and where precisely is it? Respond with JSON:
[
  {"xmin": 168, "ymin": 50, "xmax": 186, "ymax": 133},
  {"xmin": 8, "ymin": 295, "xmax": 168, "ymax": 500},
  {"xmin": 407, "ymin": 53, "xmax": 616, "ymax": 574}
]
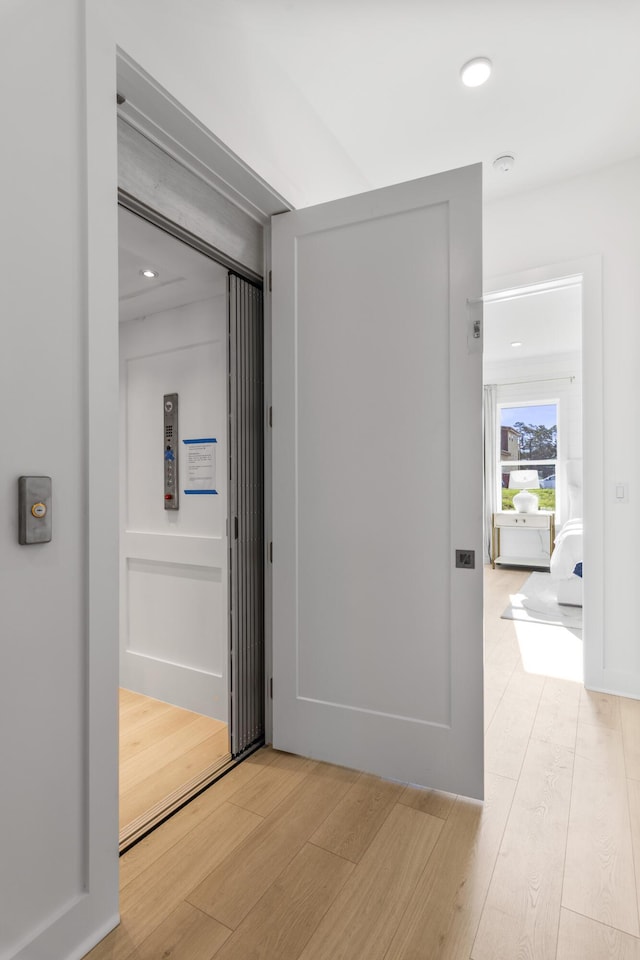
[{"xmin": 88, "ymin": 570, "xmax": 640, "ymax": 960}]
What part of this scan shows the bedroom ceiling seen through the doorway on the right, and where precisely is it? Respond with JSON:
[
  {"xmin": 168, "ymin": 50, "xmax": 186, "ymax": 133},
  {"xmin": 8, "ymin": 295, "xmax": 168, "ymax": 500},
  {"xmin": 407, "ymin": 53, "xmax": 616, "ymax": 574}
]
[{"xmin": 483, "ymin": 286, "xmax": 582, "ymax": 363}]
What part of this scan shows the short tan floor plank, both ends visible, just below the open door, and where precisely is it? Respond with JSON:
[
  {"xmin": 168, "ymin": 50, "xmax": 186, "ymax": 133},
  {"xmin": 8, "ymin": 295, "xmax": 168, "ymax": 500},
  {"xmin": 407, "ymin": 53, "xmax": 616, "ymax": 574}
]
[{"xmin": 311, "ymin": 773, "xmax": 404, "ymax": 863}]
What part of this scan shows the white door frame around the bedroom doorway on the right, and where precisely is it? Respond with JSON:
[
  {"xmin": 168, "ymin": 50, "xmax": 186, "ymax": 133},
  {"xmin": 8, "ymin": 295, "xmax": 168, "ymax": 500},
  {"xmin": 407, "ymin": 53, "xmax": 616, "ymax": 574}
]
[{"xmin": 484, "ymin": 254, "xmax": 607, "ymax": 692}]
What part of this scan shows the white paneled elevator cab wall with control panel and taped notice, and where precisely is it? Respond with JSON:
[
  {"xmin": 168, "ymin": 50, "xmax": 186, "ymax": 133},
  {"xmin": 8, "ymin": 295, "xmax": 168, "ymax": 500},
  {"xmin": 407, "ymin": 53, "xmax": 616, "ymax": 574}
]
[{"xmin": 120, "ymin": 284, "xmax": 229, "ymax": 721}]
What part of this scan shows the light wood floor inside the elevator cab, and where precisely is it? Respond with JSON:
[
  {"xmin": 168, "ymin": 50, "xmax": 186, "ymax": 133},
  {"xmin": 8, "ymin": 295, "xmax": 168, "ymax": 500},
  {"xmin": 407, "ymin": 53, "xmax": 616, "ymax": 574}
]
[{"xmin": 120, "ymin": 689, "xmax": 229, "ymax": 842}]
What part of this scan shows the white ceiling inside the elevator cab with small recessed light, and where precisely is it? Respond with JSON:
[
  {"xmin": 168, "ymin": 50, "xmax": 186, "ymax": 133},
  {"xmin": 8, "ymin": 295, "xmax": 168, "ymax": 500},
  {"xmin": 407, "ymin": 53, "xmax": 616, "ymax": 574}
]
[{"xmin": 118, "ymin": 207, "xmax": 227, "ymax": 323}]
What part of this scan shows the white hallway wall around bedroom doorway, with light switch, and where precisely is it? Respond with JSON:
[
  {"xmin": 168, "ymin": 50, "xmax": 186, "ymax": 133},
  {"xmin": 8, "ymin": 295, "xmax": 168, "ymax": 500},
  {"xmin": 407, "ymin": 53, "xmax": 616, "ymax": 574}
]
[{"xmin": 484, "ymin": 159, "xmax": 640, "ymax": 697}]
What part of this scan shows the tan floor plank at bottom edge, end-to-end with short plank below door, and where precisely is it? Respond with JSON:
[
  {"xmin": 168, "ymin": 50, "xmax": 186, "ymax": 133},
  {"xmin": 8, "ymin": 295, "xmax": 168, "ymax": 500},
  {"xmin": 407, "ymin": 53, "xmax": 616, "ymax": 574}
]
[{"xmin": 216, "ymin": 843, "xmax": 354, "ymax": 960}]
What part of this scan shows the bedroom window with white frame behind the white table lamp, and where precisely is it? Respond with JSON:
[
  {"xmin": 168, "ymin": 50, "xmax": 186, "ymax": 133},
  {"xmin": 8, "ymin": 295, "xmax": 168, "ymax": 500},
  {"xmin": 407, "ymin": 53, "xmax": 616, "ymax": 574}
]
[{"xmin": 498, "ymin": 401, "xmax": 558, "ymax": 510}]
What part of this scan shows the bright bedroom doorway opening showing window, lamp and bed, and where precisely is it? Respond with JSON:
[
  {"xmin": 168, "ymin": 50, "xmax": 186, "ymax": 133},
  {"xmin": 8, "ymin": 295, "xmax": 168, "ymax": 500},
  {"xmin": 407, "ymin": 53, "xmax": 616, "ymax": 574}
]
[{"xmin": 483, "ymin": 274, "xmax": 586, "ymax": 736}]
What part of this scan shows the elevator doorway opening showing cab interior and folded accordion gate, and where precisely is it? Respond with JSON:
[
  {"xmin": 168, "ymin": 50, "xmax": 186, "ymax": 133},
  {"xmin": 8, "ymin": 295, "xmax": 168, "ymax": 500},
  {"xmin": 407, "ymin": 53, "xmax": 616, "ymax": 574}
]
[{"xmin": 119, "ymin": 205, "xmax": 264, "ymax": 850}]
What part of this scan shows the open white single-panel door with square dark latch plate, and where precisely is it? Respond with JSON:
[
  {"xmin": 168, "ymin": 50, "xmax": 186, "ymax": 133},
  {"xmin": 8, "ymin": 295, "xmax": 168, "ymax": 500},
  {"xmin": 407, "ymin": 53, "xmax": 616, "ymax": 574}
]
[{"xmin": 272, "ymin": 165, "xmax": 483, "ymax": 798}]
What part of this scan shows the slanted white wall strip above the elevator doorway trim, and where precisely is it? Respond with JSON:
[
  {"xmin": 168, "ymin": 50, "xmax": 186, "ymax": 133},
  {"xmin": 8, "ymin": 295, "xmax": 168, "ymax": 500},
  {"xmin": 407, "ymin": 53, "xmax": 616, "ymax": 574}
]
[{"xmin": 109, "ymin": 0, "xmax": 371, "ymax": 207}]
